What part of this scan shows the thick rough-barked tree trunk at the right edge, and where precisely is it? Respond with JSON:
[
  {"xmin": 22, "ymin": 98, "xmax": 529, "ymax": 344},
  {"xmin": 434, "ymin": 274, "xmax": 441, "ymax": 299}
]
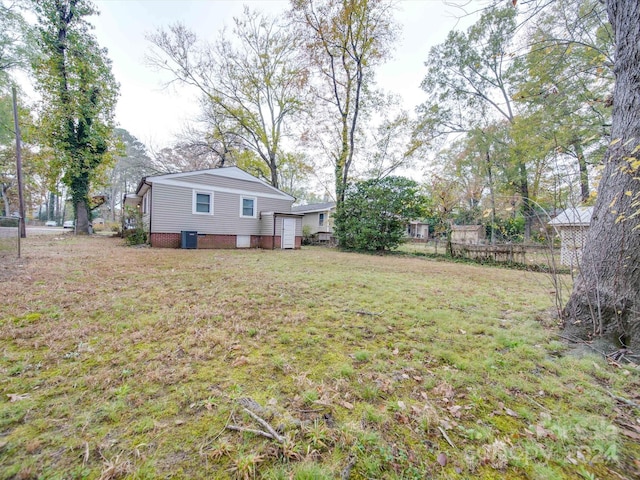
[{"xmin": 564, "ymin": 0, "xmax": 640, "ymax": 348}]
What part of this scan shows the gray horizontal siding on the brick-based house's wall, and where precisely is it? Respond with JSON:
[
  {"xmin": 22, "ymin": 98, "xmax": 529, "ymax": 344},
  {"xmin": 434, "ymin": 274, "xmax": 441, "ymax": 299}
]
[{"xmin": 151, "ymin": 182, "xmax": 292, "ymax": 235}]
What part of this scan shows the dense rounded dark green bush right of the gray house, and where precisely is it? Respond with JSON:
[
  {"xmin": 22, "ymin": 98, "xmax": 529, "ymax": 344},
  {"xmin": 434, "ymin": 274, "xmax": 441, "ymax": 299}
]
[{"xmin": 334, "ymin": 176, "xmax": 426, "ymax": 251}]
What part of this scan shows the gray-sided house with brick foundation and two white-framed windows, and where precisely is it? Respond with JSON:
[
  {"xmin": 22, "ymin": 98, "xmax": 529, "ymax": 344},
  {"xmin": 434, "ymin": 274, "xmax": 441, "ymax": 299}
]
[{"xmin": 124, "ymin": 167, "xmax": 302, "ymax": 249}]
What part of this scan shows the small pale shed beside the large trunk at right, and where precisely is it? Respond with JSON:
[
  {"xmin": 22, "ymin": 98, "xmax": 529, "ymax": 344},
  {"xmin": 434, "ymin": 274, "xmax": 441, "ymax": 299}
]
[{"xmin": 549, "ymin": 207, "xmax": 593, "ymax": 267}]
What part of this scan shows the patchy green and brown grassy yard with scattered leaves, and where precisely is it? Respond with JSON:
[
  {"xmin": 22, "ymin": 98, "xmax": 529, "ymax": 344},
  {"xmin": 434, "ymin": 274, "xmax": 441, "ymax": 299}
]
[{"xmin": 0, "ymin": 235, "xmax": 640, "ymax": 480}]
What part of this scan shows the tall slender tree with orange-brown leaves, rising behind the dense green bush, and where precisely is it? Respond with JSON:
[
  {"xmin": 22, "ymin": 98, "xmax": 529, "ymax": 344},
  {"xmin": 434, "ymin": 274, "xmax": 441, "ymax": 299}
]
[{"xmin": 292, "ymin": 0, "xmax": 395, "ymax": 205}]
